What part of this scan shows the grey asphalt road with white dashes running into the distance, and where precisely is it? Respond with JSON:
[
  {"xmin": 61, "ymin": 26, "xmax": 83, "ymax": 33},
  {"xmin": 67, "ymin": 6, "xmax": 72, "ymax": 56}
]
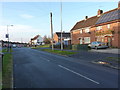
[{"xmin": 13, "ymin": 48, "xmax": 118, "ymax": 88}]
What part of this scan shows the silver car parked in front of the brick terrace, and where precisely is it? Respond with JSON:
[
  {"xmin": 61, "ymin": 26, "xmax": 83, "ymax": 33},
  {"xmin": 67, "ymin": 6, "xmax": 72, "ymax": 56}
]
[{"xmin": 88, "ymin": 41, "xmax": 108, "ymax": 49}]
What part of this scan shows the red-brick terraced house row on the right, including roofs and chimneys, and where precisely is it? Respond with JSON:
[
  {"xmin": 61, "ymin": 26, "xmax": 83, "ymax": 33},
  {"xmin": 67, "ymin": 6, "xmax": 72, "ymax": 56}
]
[{"xmin": 70, "ymin": 2, "xmax": 120, "ymax": 48}]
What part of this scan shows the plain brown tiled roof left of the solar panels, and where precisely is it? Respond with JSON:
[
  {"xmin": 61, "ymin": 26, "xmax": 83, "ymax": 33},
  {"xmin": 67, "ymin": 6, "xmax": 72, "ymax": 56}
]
[{"xmin": 71, "ymin": 16, "xmax": 99, "ymax": 31}]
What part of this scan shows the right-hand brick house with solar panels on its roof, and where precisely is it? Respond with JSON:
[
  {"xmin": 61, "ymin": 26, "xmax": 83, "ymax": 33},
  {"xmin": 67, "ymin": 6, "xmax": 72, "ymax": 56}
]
[{"xmin": 95, "ymin": 2, "xmax": 120, "ymax": 48}]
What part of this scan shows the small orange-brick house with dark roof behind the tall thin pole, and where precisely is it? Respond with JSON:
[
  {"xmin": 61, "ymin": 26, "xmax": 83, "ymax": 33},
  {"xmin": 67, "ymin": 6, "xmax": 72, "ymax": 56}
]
[{"xmin": 53, "ymin": 32, "xmax": 71, "ymax": 45}]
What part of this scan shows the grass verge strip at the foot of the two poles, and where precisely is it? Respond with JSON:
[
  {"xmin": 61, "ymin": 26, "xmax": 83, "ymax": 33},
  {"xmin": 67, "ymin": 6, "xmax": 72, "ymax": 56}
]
[{"xmin": 42, "ymin": 49, "xmax": 76, "ymax": 55}]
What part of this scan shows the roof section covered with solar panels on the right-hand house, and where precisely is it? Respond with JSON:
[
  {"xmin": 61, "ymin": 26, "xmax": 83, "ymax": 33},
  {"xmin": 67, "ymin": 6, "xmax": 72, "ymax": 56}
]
[{"xmin": 96, "ymin": 8, "xmax": 120, "ymax": 24}]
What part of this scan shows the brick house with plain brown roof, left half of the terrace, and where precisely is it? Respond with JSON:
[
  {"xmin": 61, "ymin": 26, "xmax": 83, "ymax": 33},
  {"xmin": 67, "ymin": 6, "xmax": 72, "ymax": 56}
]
[{"xmin": 70, "ymin": 15, "xmax": 99, "ymax": 44}]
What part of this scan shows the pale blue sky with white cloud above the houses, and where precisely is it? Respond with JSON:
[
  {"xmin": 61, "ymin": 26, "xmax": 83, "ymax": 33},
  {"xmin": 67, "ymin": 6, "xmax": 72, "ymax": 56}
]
[{"xmin": 0, "ymin": 1, "xmax": 118, "ymax": 42}]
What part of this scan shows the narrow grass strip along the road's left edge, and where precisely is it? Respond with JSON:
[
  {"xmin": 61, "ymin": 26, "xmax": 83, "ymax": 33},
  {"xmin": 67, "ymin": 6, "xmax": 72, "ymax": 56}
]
[{"xmin": 2, "ymin": 49, "xmax": 13, "ymax": 88}]
